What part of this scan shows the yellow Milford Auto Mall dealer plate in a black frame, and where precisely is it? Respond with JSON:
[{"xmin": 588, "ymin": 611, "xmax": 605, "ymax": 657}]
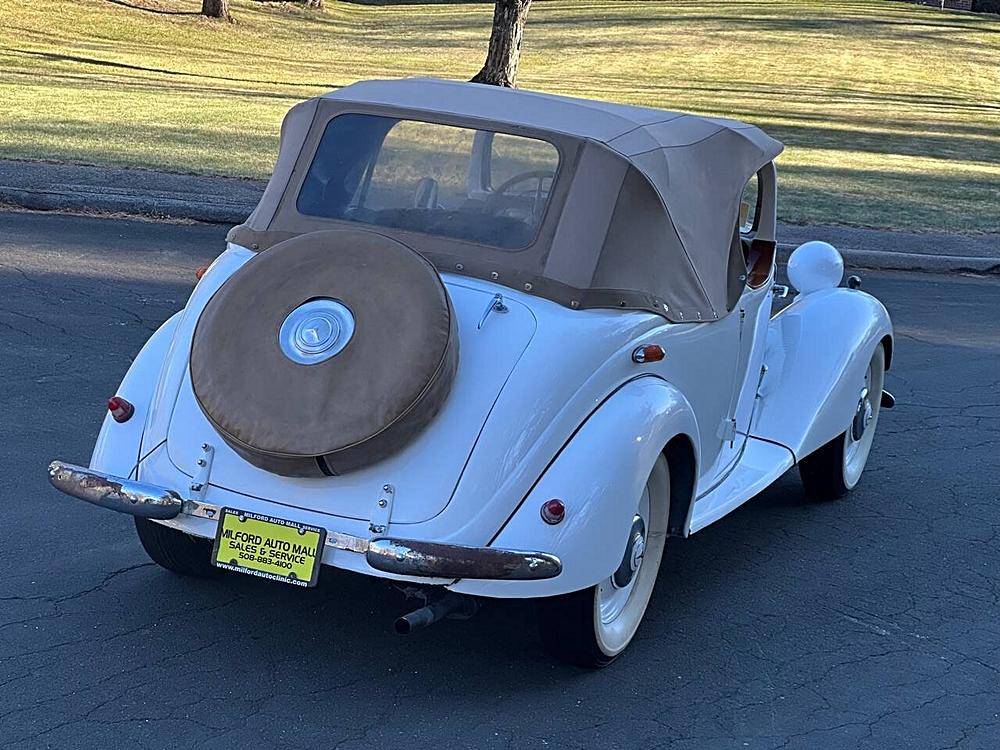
[{"xmin": 212, "ymin": 508, "xmax": 326, "ymax": 586}]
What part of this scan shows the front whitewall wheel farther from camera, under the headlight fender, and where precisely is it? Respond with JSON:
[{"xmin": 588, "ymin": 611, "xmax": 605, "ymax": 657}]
[{"xmin": 799, "ymin": 344, "xmax": 885, "ymax": 500}]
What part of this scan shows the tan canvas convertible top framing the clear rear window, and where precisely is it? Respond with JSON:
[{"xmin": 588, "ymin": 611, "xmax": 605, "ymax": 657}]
[{"xmin": 229, "ymin": 79, "xmax": 782, "ymax": 322}]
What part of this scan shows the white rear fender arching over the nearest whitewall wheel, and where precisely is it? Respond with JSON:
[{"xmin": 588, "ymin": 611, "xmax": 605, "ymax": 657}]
[{"xmin": 451, "ymin": 376, "xmax": 700, "ymax": 598}]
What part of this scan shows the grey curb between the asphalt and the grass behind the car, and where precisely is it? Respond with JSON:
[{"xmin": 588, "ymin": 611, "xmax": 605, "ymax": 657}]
[{"xmin": 0, "ymin": 185, "xmax": 1000, "ymax": 275}]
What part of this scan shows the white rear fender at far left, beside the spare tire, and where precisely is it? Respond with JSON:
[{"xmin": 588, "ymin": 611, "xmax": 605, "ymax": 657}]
[{"xmin": 90, "ymin": 312, "xmax": 181, "ymax": 478}]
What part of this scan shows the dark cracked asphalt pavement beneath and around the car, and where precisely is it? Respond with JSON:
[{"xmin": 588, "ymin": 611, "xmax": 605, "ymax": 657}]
[{"xmin": 0, "ymin": 213, "xmax": 1000, "ymax": 750}]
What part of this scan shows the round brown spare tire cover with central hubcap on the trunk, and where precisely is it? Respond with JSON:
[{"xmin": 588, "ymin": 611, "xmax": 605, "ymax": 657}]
[{"xmin": 191, "ymin": 230, "xmax": 458, "ymax": 476}]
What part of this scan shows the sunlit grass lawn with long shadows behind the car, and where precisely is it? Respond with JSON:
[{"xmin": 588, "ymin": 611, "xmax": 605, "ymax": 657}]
[{"xmin": 0, "ymin": 0, "xmax": 1000, "ymax": 232}]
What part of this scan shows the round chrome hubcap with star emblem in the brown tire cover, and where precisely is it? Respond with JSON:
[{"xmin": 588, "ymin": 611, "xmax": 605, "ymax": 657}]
[{"xmin": 278, "ymin": 299, "xmax": 354, "ymax": 365}]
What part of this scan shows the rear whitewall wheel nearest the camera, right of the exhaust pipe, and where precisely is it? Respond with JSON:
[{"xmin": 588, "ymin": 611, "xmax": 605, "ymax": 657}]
[{"xmin": 538, "ymin": 454, "xmax": 670, "ymax": 668}]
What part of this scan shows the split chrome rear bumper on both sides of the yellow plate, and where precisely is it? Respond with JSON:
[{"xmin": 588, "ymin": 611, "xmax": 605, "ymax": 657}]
[{"xmin": 49, "ymin": 461, "xmax": 562, "ymax": 581}]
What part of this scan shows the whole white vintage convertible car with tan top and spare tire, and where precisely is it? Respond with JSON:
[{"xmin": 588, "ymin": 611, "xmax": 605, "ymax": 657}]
[{"xmin": 49, "ymin": 79, "xmax": 892, "ymax": 666}]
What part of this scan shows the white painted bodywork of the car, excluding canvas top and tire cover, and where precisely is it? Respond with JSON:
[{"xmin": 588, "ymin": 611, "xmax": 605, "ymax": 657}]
[{"xmin": 84, "ymin": 245, "xmax": 892, "ymax": 597}]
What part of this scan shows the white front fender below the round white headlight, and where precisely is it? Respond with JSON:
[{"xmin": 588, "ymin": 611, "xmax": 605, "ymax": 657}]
[{"xmin": 750, "ymin": 288, "xmax": 892, "ymax": 460}]
